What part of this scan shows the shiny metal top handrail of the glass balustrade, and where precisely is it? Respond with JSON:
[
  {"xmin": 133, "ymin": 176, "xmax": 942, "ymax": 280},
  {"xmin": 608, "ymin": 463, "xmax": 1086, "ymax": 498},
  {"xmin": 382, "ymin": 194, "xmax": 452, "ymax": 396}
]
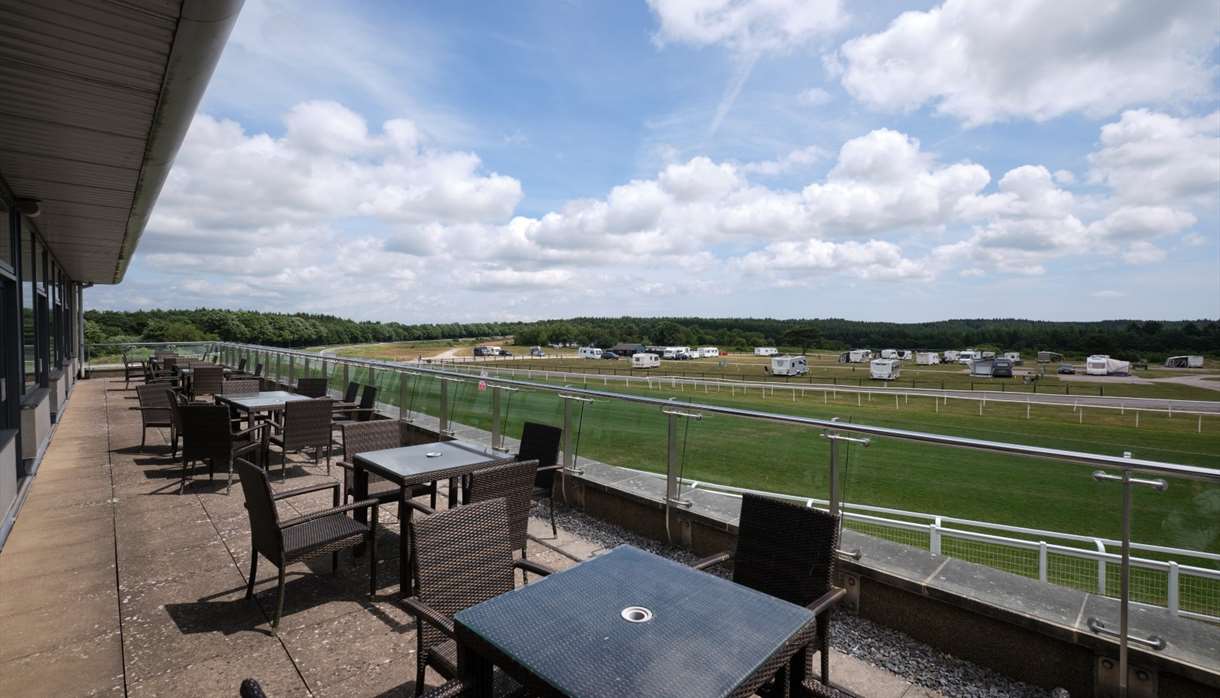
[{"xmin": 218, "ymin": 342, "xmax": 1220, "ymax": 483}]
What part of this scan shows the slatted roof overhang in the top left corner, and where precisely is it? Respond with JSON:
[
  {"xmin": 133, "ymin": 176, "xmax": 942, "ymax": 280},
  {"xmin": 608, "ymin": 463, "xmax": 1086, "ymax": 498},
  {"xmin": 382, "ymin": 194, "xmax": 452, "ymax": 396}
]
[{"xmin": 0, "ymin": 0, "xmax": 244, "ymax": 283}]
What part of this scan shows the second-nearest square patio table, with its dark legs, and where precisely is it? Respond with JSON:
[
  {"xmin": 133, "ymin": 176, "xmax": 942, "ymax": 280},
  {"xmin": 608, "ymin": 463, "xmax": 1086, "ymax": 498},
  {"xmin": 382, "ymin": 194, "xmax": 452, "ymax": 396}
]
[{"xmin": 351, "ymin": 441, "xmax": 505, "ymax": 595}]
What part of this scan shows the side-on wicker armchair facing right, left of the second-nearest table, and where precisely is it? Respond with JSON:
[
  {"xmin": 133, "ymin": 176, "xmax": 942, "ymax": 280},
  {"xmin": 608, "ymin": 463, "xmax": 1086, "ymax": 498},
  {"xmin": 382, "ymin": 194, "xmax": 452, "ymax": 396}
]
[{"xmin": 237, "ymin": 459, "xmax": 377, "ymax": 633}]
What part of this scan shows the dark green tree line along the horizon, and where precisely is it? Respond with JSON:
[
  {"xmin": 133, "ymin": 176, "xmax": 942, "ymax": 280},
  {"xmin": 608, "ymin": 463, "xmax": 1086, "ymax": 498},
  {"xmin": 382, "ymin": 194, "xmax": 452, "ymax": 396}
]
[{"xmin": 85, "ymin": 309, "xmax": 1220, "ymax": 361}]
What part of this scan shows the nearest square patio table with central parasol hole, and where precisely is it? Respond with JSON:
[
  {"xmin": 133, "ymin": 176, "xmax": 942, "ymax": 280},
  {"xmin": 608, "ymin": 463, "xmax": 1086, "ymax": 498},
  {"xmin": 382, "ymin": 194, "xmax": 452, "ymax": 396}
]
[{"xmin": 454, "ymin": 545, "xmax": 816, "ymax": 698}]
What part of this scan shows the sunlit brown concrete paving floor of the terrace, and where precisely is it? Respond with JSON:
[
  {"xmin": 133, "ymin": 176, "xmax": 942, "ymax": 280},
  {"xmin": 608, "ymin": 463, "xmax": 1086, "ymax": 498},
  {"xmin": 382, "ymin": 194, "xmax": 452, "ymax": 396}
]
[{"xmin": 0, "ymin": 378, "xmax": 935, "ymax": 698}]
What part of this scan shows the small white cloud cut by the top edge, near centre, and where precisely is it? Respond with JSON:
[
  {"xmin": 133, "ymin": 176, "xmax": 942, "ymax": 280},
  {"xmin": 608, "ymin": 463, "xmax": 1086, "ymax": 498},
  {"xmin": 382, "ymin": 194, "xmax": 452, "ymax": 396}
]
[{"xmin": 648, "ymin": 0, "xmax": 847, "ymax": 54}]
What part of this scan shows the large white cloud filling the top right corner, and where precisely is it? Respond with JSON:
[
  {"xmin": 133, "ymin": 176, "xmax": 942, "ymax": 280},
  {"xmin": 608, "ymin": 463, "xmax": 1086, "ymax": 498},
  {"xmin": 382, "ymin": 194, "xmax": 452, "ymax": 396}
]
[{"xmin": 830, "ymin": 0, "xmax": 1218, "ymax": 126}]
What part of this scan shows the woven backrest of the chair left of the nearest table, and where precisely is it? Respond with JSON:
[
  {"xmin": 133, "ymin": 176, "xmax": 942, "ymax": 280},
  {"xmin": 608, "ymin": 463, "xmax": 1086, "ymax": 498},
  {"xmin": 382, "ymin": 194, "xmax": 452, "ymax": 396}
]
[{"xmin": 412, "ymin": 499, "xmax": 512, "ymax": 663}]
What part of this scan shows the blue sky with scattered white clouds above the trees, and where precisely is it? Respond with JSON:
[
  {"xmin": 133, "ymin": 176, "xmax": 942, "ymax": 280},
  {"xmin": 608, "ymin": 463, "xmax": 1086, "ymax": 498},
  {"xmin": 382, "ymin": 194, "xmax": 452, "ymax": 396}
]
[{"xmin": 87, "ymin": 0, "xmax": 1220, "ymax": 322}]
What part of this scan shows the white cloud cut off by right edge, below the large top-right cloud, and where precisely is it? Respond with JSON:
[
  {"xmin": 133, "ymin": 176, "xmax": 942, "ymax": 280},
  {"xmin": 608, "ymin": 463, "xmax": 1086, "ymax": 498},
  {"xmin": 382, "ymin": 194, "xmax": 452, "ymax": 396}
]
[{"xmin": 1088, "ymin": 109, "xmax": 1220, "ymax": 205}]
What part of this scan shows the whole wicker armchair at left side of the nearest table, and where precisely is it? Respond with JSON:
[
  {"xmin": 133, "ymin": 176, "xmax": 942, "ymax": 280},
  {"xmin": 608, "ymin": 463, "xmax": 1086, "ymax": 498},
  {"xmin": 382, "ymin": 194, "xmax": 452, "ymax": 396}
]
[{"xmin": 404, "ymin": 491, "xmax": 553, "ymax": 696}]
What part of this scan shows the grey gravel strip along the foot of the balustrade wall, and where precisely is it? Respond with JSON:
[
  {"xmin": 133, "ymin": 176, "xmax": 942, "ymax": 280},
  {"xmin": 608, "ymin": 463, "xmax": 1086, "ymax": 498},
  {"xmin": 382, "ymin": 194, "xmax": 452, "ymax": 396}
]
[{"xmin": 532, "ymin": 503, "xmax": 1068, "ymax": 698}]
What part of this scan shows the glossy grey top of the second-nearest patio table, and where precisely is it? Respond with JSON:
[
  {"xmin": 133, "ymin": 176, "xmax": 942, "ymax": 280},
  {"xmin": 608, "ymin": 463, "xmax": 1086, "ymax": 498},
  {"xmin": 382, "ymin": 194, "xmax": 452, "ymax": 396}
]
[{"xmin": 353, "ymin": 441, "xmax": 505, "ymax": 487}]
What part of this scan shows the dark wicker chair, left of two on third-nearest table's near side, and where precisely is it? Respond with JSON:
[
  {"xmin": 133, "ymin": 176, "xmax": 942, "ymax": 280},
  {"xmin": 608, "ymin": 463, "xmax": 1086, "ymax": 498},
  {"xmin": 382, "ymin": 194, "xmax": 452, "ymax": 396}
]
[{"xmin": 178, "ymin": 404, "xmax": 271, "ymax": 494}]
